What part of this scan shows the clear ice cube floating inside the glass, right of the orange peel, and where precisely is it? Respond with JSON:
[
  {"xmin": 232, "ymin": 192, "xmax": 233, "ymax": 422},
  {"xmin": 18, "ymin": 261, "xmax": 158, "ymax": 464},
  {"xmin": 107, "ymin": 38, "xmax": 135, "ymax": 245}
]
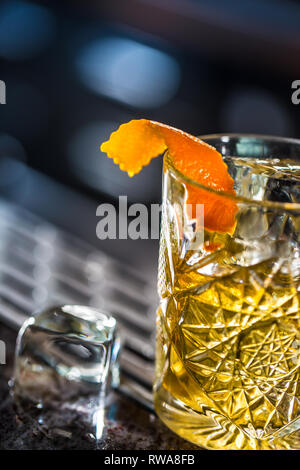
[{"xmin": 226, "ymin": 157, "xmax": 300, "ymax": 268}]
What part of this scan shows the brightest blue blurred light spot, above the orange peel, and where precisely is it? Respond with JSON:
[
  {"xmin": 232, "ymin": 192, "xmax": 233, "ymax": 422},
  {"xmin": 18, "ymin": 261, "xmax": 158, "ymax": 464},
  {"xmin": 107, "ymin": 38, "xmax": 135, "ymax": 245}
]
[{"xmin": 76, "ymin": 37, "xmax": 180, "ymax": 108}]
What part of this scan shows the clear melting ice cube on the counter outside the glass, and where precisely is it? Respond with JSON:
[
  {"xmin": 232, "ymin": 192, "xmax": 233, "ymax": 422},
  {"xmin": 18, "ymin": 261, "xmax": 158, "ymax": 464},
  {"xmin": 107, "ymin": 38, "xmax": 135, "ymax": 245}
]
[{"xmin": 12, "ymin": 305, "xmax": 120, "ymax": 437}]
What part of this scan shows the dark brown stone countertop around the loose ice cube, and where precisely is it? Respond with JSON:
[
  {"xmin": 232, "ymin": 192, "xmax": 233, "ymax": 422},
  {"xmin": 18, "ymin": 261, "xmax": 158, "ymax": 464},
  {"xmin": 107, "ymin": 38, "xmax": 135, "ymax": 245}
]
[{"xmin": 0, "ymin": 323, "xmax": 199, "ymax": 450}]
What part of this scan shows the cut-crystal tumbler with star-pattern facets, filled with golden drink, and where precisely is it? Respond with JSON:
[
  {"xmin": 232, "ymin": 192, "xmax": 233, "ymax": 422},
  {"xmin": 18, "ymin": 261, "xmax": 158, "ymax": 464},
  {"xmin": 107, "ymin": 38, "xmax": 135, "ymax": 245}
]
[{"xmin": 154, "ymin": 137, "xmax": 300, "ymax": 449}]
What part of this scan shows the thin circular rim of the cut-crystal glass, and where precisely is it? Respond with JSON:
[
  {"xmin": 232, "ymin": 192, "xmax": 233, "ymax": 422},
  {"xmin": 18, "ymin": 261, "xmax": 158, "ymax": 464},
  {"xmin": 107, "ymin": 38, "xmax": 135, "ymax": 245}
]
[{"xmin": 164, "ymin": 133, "xmax": 300, "ymax": 212}]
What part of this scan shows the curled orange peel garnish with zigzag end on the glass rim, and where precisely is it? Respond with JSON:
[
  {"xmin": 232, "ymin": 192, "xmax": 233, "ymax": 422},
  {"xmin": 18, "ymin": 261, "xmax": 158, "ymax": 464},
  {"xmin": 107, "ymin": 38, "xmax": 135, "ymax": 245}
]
[{"xmin": 101, "ymin": 119, "xmax": 237, "ymax": 233}]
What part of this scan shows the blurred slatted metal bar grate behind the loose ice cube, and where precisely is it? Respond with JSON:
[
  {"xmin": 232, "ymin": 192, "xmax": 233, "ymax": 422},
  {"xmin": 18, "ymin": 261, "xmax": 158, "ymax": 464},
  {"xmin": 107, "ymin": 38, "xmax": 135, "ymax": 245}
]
[{"xmin": 0, "ymin": 201, "xmax": 156, "ymax": 410}]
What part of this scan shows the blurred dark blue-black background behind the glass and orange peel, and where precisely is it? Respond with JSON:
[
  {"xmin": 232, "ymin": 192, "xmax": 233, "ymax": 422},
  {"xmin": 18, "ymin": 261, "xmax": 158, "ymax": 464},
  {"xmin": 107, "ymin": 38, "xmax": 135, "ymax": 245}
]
[{"xmin": 0, "ymin": 0, "xmax": 300, "ymax": 272}]
